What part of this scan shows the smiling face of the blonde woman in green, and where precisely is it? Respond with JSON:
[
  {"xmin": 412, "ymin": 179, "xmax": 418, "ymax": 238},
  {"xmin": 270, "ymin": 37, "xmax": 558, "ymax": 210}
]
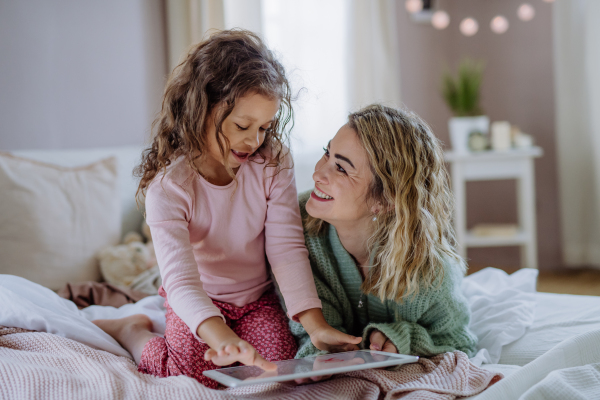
[{"xmin": 306, "ymin": 125, "xmax": 373, "ymax": 227}]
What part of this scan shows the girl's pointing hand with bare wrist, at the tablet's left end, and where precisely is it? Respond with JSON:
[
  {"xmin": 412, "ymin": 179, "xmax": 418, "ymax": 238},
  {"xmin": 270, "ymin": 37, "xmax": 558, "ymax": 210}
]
[{"xmin": 197, "ymin": 317, "xmax": 277, "ymax": 371}]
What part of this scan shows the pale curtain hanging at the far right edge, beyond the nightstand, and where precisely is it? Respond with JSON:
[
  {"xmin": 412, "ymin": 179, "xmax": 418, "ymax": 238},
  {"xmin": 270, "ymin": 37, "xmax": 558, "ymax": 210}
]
[{"xmin": 554, "ymin": 0, "xmax": 600, "ymax": 268}]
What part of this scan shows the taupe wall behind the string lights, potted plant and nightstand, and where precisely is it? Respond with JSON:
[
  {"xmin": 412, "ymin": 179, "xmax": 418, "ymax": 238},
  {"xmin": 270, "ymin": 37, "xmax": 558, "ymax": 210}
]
[{"xmin": 399, "ymin": 0, "xmax": 561, "ymax": 270}]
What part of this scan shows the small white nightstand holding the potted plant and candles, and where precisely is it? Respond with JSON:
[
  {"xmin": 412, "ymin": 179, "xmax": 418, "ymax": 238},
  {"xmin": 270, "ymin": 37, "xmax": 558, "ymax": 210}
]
[{"xmin": 444, "ymin": 147, "xmax": 543, "ymax": 268}]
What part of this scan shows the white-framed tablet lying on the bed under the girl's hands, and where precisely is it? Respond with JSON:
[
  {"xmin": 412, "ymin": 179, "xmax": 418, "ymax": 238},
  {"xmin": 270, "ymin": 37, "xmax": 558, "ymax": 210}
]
[{"xmin": 203, "ymin": 350, "xmax": 419, "ymax": 387}]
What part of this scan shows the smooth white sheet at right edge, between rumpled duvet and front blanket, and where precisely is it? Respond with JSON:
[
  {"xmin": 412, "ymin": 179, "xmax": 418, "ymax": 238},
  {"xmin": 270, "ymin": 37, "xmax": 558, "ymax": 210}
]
[{"xmin": 499, "ymin": 293, "xmax": 600, "ymax": 366}]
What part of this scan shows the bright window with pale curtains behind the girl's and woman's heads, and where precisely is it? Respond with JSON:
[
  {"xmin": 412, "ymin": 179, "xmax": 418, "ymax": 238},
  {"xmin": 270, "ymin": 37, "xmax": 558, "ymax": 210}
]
[{"xmin": 162, "ymin": 0, "xmax": 400, "ymax": 190}]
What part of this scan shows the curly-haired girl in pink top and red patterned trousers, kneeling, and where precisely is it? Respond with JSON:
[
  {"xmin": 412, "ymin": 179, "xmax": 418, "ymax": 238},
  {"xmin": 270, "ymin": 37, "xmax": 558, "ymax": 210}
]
[{"xmin": 95, "ymin": 30, "xmax": 361, "ymax": 388}]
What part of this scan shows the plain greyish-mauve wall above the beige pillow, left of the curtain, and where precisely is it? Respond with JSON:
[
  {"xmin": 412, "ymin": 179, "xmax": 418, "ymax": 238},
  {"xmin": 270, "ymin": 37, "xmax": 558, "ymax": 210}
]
[{"xmin": 0, "ymin": 0, "xmax": 167, "ymax": 150}]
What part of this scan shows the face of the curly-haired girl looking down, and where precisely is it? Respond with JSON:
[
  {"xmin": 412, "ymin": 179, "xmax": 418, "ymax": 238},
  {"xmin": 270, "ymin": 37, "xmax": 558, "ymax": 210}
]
[{"xmin": 207, "ymin": 93, "xmax": 280, "ymax": 169}]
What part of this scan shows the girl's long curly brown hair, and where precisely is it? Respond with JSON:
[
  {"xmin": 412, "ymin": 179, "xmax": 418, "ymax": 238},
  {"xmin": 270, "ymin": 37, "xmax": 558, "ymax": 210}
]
[{"xmin": 134, "ymin": 29, "xmax": 293, "ymax": 195}]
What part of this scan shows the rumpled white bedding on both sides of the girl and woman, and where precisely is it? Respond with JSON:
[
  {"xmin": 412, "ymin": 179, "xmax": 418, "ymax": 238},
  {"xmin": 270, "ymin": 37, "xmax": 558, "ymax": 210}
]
[{"xmin": 0, "ymin": 268, "xmax": 600, "ymax": 400}]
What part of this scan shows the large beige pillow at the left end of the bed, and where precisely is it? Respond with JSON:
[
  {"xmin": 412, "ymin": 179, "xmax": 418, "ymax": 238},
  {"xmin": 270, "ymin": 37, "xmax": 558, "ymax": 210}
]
[{"xmin": 0, "ymin": 152, "xmax": 121, "ymax": 290}]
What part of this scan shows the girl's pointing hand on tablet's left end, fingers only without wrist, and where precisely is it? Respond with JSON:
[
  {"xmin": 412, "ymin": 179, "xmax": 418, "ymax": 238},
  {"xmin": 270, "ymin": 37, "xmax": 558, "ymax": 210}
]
[{"xmin": 204, "ymin": 338, "xmax": 277, "ymax": 371}]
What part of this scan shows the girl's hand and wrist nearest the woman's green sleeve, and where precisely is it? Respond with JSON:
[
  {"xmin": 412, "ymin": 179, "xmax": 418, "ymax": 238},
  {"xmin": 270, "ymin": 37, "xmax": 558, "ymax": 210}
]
[{"xmin": 298, "ymin": 308, "xmax": 362, "ymax": 352}]
